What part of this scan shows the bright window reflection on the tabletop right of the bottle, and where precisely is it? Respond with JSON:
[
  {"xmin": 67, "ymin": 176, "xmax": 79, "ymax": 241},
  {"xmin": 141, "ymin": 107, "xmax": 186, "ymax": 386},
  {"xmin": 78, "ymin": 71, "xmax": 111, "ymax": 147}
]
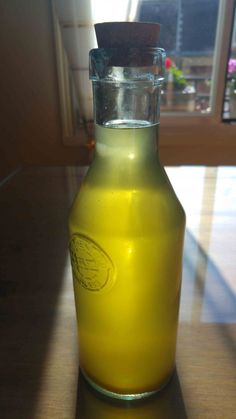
[{"xmin": 167, "ymin": 167, "xmax": 236, "ymax": 323}]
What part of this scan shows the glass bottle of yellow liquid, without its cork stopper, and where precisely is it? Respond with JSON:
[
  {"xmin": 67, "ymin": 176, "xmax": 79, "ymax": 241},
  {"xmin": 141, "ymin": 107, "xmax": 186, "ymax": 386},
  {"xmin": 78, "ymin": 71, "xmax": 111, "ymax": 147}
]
[{"xmin": 69, "ymin": 47, "xmax": 185, "ymax": 399}]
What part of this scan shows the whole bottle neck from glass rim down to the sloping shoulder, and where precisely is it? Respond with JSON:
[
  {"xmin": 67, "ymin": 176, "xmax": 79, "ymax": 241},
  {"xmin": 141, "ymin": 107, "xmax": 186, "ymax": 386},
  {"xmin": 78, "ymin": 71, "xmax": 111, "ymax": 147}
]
[{"xmin": 90, "ymin": 47, "xmax": 165, "ymax": 164}]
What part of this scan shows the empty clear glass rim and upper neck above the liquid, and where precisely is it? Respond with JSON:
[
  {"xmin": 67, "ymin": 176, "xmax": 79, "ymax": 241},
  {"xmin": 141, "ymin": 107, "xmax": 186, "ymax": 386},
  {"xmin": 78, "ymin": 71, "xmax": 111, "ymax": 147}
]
[{"xmin": 89, "ymin": 47, "xmax": 165, "ymax": 126}]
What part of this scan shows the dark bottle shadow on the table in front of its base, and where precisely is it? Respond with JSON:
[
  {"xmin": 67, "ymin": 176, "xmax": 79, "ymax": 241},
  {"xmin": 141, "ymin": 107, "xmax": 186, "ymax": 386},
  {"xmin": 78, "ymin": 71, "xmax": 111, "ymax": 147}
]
[{"xmin": 75, "ymin": 371, "xmax": 187, "ymax": 419}]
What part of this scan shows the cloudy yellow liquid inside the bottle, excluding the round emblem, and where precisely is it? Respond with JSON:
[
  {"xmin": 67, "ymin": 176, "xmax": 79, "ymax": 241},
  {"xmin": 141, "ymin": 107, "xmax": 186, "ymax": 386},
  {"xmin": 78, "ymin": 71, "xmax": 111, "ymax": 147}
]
[{"xmin": 69, "ymin": 126, "xmax": 185, "ymax": 394}]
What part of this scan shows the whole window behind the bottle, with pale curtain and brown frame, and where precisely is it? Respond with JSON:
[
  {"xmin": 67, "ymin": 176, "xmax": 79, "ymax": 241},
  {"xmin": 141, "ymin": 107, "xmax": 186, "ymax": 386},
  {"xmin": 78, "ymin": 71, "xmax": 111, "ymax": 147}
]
[{"xmin": 52, "ymin": 0, "xmax": 236, "ymax": 164}]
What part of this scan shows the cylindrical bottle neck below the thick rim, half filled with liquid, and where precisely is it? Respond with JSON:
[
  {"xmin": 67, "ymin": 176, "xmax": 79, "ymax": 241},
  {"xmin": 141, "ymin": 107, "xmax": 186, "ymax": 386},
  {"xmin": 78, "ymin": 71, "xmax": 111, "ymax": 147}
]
[{"xmin": 93, "ymin": 81, "xmax": 160, "ymax": 163}]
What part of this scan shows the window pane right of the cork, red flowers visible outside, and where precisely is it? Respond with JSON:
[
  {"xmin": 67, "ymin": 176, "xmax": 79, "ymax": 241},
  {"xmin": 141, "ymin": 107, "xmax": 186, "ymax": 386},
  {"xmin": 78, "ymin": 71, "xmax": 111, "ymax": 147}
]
[{"xmin": 138, "ymin": 0, "xmax": 219, "ymax": 113}]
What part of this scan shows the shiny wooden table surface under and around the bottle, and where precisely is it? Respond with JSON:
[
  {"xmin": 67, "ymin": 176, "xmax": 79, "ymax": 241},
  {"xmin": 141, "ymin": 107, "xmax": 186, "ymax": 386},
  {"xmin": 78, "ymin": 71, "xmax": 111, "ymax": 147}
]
[{"xmin": 0, "ymin": 167, "xmax": 236, "ymax": 419}]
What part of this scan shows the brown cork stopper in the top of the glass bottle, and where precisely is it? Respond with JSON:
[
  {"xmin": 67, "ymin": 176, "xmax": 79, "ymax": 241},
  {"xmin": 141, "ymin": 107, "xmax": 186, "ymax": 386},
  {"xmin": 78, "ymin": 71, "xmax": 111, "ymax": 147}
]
[{"xmin": 95, "ymin": 22, "xmax": 160, "ymax": 48}]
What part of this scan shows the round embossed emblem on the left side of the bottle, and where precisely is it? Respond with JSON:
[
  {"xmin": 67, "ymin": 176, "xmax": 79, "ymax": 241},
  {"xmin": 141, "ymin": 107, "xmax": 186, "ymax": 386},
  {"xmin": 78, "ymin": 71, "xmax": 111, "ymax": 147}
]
[{"xmin": 70, "ymin": 234, "xmax": 114, "ymax": 291}]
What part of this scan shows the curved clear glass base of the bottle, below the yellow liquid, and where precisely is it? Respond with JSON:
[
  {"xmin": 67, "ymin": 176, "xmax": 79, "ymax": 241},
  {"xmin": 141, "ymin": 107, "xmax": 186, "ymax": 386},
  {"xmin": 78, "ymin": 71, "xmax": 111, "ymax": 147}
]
[{"xmin": 80, "ymin": 368, "xmax": 171, "ymax": 400}]
